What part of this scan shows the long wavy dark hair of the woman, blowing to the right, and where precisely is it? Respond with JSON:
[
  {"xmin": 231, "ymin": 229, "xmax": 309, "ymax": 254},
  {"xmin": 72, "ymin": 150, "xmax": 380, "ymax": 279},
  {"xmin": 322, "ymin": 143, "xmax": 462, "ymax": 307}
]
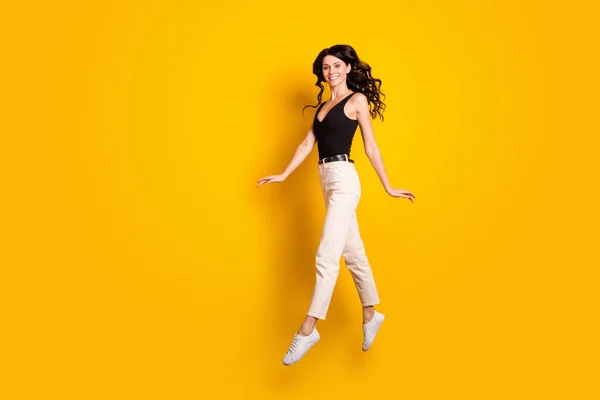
[{"xmin": 302, "ymin": 44, "xmax": 385, "ymax": 121}]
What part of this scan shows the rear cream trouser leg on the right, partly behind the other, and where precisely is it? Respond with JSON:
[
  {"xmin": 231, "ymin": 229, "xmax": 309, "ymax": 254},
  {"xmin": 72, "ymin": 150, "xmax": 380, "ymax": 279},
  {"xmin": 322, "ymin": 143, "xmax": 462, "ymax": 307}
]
[{"xmin": 343, "ymin": 212, "xmax": 379, "ymax": 307}]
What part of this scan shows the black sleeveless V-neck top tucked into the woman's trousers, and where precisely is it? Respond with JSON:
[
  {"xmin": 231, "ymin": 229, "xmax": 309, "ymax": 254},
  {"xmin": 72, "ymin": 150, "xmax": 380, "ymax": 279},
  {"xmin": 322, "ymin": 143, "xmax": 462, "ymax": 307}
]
[{"xmin": 313, "ymin": 92, "xmax": 358, "ymax": 159}]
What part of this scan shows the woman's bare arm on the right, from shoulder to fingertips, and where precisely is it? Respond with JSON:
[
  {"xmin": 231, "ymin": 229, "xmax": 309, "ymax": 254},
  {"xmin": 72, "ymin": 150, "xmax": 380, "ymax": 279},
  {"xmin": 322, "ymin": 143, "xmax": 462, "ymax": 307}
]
[{"xmin": 352, "ymin": 94, "xmax": 415, "ymax": 202}]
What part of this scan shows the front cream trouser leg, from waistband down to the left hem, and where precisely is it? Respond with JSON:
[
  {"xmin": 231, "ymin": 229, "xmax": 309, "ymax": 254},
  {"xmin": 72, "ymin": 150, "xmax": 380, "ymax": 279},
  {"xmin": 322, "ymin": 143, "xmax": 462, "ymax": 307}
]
[{"xmin": 308, "ymin": 163, "xmax": 360, "ymax": 319}]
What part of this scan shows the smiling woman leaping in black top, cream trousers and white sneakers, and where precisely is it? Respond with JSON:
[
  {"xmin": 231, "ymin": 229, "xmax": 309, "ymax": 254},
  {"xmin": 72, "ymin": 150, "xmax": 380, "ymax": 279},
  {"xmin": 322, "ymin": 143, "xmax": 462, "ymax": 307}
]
[{"xmin": 258, "ymin": 45, "xmax": 415, "ymax": 365}]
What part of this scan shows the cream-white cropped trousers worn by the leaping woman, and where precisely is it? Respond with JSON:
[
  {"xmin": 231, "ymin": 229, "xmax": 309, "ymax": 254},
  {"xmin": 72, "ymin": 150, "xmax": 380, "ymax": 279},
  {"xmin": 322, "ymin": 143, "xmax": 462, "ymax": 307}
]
[{"xmin": 308, "ymin": 161, "xmax": 379, "ymax": 319}]
